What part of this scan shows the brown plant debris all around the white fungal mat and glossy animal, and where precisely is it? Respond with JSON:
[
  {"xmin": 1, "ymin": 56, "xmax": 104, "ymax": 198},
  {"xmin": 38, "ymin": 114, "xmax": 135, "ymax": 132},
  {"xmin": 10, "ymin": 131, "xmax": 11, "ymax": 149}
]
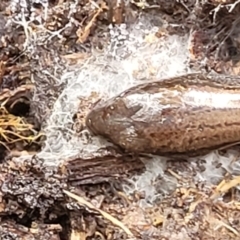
[{"xmin": 0, "ymin": 0, "xmax": 240, "ymax": 240}]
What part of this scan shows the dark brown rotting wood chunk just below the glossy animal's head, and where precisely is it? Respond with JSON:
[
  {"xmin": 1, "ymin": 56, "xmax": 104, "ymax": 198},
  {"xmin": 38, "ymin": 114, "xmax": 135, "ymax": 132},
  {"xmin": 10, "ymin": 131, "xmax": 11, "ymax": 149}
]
[{"xmin": 62, "ymin": 155, "xmax": 144, "ymax": 186}]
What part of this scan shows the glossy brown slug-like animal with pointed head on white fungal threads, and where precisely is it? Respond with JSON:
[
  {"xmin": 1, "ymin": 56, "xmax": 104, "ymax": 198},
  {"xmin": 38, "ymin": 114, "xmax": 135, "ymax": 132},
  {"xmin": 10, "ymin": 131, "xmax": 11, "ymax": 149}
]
[{"xmin": 86, "ymin": 74, "xmax": 240, "ymax": 156}]
